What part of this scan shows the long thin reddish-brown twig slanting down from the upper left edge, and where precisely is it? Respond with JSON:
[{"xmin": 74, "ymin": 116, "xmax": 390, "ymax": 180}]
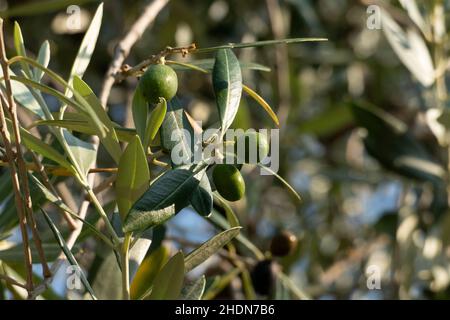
[{"xmin": 0, "ymin": 20, "xmax": 51, "ymax": 278}]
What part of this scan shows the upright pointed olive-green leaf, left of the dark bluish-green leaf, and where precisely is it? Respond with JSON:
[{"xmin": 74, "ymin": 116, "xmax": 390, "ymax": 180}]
[{"xmin": 115, "ymin": 136, "xmax": 150, "ymax": 220}]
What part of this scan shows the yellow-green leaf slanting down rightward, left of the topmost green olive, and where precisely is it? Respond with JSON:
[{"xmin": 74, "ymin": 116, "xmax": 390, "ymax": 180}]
[{"xmin": 73, "ymin": 75, "xmax": 122, "ymax": 163}]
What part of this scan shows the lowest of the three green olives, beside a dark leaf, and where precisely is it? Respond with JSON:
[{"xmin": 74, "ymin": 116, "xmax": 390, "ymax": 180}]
[{"xmin": 213, "ymin": 164, "xmax": 245, "ymax": 201}]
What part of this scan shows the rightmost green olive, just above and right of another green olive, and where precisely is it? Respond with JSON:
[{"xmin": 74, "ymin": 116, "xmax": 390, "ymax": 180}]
[{"xmin": 234, "ymin": 131, "xmax": 269, "ymax": 164}]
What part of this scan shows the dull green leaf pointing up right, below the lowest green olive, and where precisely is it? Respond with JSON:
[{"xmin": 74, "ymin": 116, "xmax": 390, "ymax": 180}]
[{"xmin": 184, "ymin": 227, "xmax": 241, "ymax": 272}]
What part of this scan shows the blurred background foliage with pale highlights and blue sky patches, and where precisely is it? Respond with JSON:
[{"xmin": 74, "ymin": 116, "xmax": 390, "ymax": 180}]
[{"xmin": 0, "ymin": 0, "xmax": 450, "ymax": 299}]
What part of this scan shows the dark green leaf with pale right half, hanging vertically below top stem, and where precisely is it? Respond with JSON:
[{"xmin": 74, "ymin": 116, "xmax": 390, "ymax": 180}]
[{"xmin": 212, "ymin": 49, "xmax": 242, "ymax": 135}]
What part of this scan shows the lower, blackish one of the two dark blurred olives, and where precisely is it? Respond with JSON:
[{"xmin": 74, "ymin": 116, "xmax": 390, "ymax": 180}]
[{"xmin": 250, "ymin": 259, "xmax": 278, "ymax": 296}]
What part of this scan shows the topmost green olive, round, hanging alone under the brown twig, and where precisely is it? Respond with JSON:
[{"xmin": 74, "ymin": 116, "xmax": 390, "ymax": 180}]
[{"xmin": 139, "ymin": 64, "xmax": 178, "ymax": 103}]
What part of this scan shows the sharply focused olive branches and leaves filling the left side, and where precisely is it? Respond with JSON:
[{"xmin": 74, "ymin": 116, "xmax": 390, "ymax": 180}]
[{"xmin": 0, "ymin": 1, "xmax": 323, "ymax": 299}]
